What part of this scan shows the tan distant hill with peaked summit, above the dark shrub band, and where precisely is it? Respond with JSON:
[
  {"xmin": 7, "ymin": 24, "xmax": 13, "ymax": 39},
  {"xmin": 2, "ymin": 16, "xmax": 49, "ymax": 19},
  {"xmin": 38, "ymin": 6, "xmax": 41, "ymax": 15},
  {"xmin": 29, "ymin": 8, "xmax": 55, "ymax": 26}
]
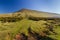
[{"xmin": 0, "ymin": 9, "xmax": 60, "ymax": 18}]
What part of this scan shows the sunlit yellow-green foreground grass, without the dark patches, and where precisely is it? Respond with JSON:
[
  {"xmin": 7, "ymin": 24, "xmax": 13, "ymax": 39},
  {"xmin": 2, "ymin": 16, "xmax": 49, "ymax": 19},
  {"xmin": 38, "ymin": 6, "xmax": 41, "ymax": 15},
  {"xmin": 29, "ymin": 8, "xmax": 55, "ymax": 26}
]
[{"xmin": 0, "ymin": 19, "xmax": 60, "ymax": 40}]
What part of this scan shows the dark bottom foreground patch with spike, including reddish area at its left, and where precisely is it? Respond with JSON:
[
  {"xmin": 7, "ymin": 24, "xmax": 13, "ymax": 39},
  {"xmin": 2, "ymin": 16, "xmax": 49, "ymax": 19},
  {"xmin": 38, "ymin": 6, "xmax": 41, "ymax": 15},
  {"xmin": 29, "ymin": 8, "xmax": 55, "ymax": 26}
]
[{"xmin": 13, "ymin": 27, "xmax": 56, "ymax": 40}]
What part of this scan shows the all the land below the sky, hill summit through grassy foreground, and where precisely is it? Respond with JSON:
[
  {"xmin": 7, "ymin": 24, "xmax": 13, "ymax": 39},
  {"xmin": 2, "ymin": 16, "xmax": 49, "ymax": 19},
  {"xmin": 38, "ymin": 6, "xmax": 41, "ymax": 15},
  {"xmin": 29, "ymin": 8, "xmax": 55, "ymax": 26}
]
[{"xmin": 0, "ymin": 9, "xmax": 60, "ymax": 40}]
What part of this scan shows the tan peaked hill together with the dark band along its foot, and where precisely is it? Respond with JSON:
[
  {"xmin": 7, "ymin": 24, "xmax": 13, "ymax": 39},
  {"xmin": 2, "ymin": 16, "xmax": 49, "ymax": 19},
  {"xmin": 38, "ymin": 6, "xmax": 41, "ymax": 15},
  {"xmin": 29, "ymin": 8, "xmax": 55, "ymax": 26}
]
[{"xmin": 0, "ymin": 9, "xmax": 60, "ymax": 21}]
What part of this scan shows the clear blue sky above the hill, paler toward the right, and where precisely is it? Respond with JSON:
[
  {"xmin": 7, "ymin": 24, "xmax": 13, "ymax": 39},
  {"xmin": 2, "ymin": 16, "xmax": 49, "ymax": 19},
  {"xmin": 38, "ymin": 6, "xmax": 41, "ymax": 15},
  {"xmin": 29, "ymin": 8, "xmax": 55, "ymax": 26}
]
[{"xmin": 0, "ymin": 0, "xmax": 60, "ymax": 14}]
